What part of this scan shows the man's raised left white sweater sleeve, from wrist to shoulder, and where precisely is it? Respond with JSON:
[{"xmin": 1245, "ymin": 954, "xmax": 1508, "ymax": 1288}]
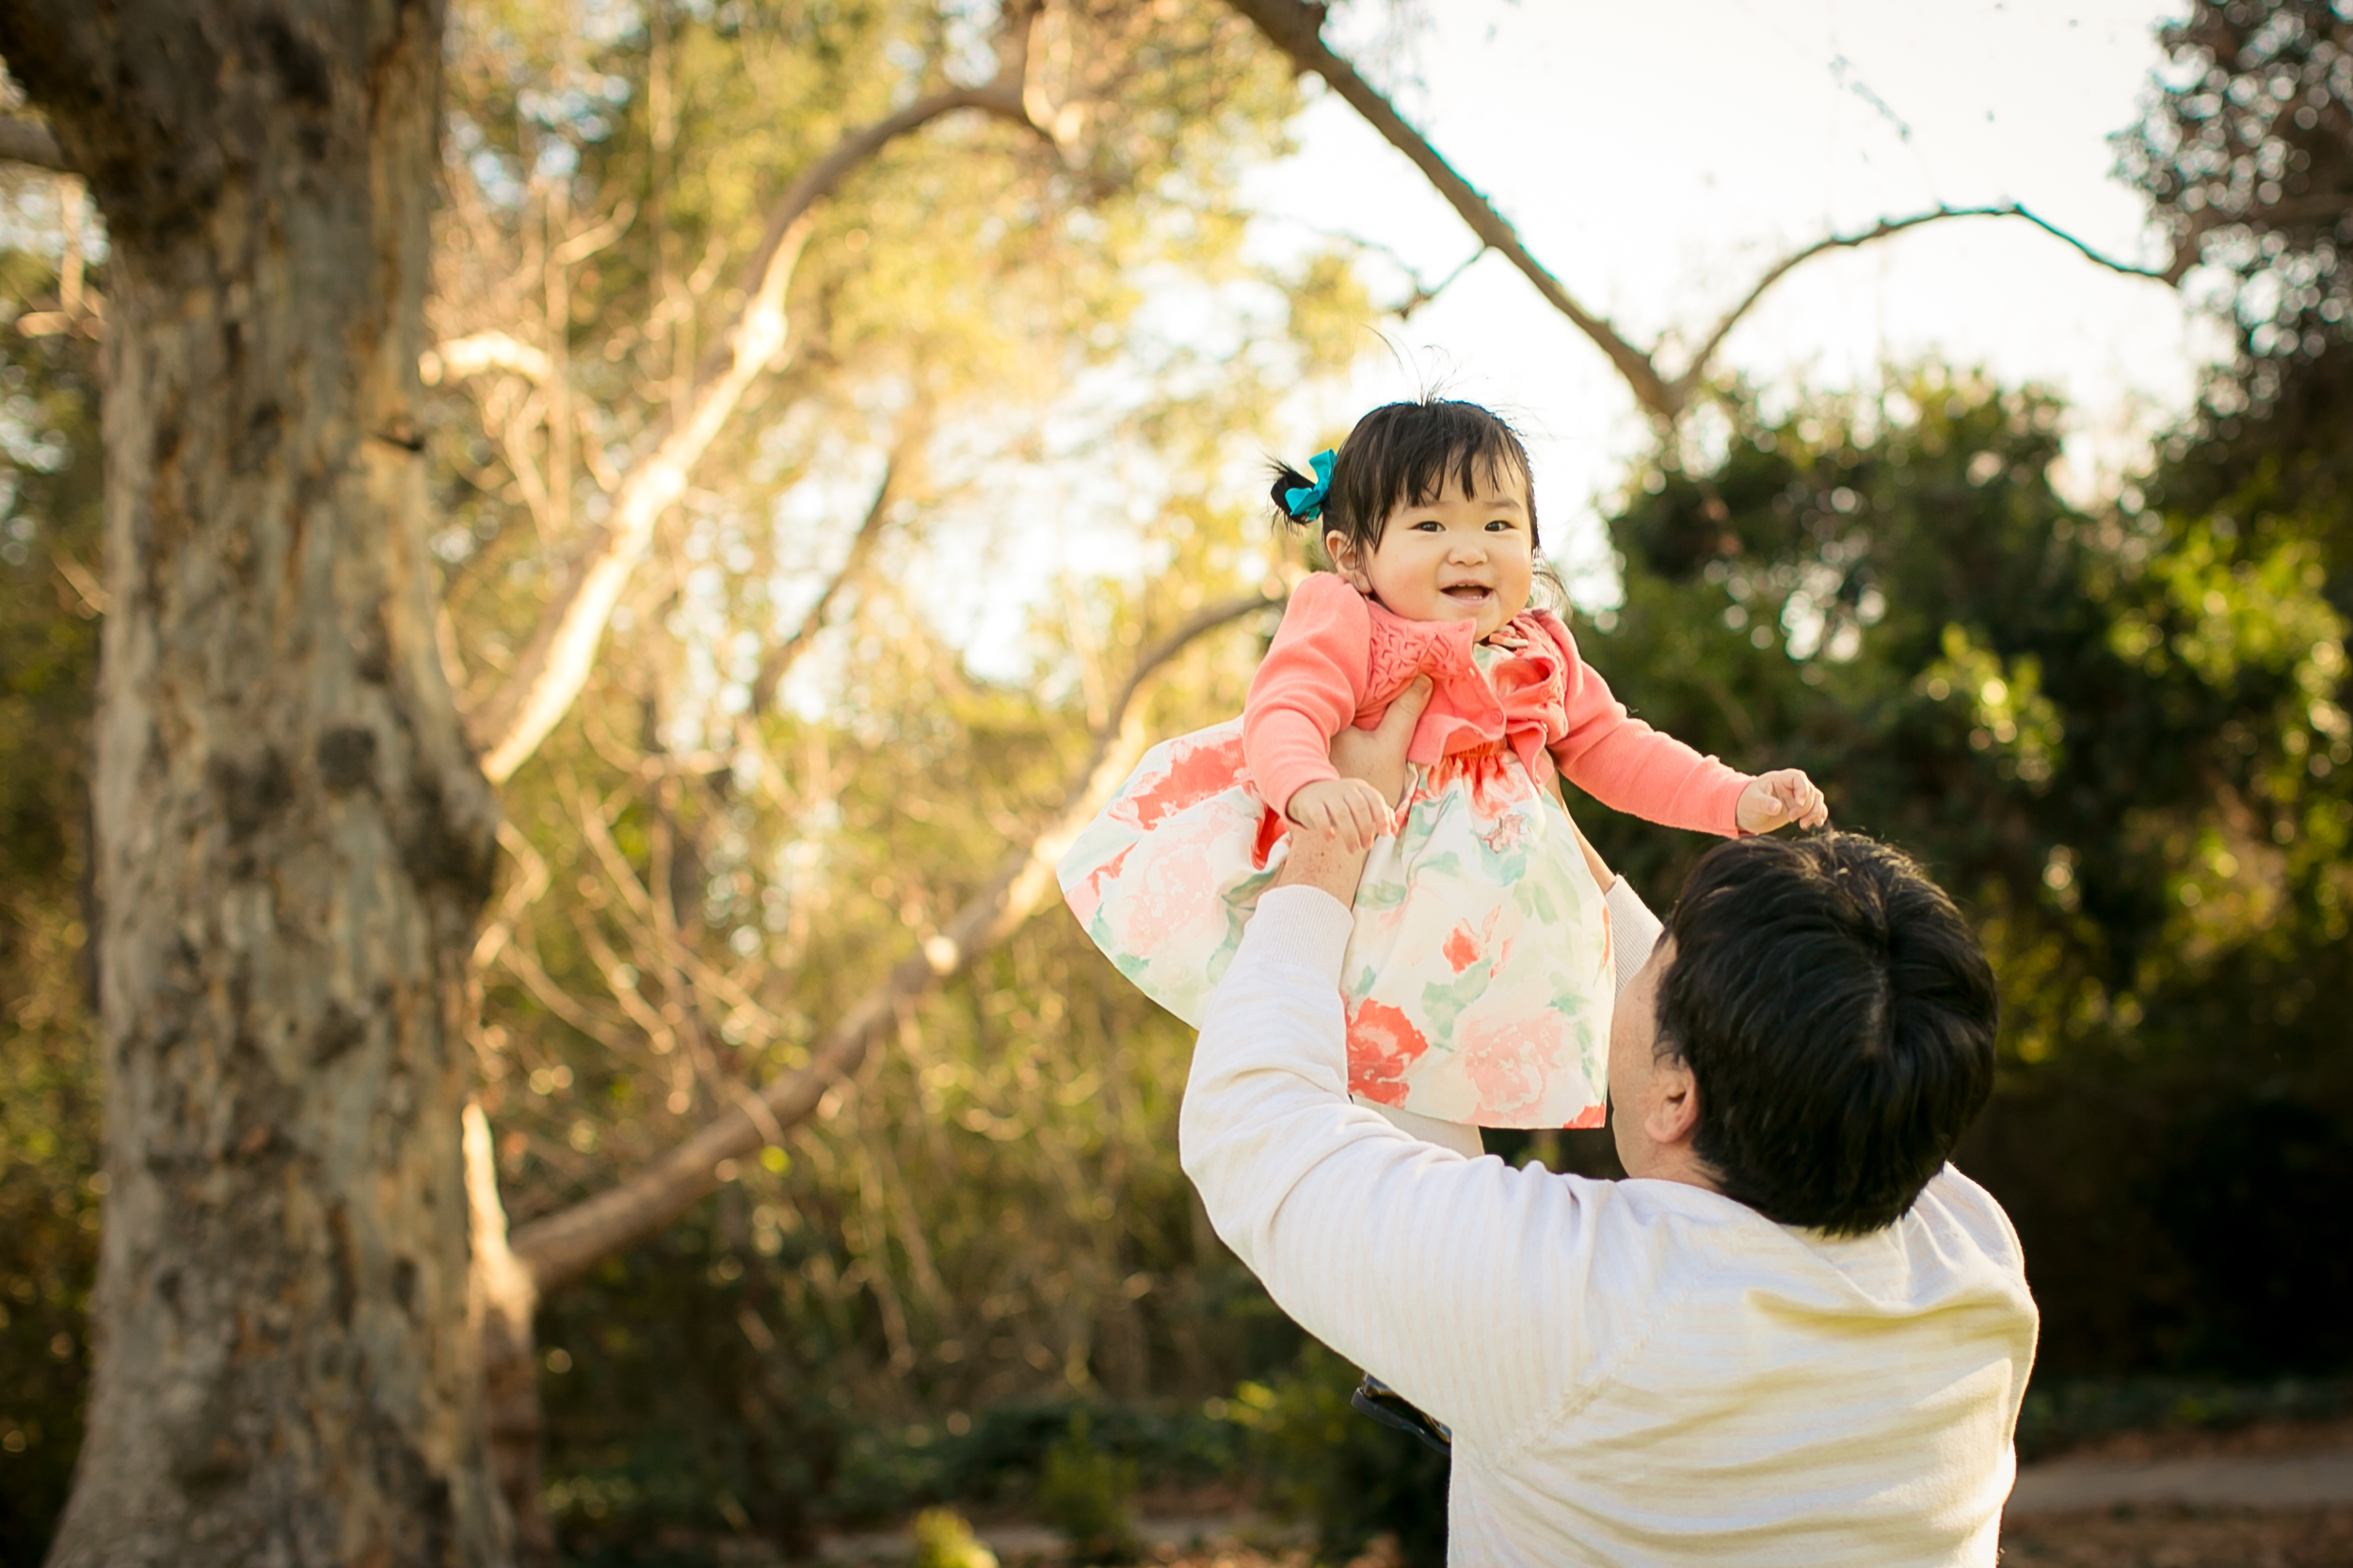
[{"xmin": 1176, "ymin": 888, "xmax": 1641, "ymax": 1448}]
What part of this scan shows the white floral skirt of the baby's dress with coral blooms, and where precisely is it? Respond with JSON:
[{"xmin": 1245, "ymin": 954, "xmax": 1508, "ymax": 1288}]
[{"xmin": 1059, "ymin": 720, "xmax": 1612, "ymax": 1128}]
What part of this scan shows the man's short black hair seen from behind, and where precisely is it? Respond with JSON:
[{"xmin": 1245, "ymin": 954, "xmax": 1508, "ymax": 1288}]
[{"xmin": 1659, "ymin": 834, "xmax": 1998, "ymax": 1236}]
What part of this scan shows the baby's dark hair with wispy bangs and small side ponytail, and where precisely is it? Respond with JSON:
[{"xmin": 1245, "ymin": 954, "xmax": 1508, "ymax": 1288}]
[{"xmin": 1273, "ymin": 398, "xmax": 1537, "ymax": 553}]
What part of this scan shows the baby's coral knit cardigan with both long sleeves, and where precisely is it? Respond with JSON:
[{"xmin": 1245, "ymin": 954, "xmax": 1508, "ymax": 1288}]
[{"xmin": 1242, "ymin": 572, "xmax": 1749, "ymax": 839}]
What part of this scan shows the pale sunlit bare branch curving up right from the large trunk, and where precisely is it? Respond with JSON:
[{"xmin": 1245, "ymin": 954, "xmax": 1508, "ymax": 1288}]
[{"xmin": 475, "ymin": 78, "xmax": 1054, "ymax": 784}]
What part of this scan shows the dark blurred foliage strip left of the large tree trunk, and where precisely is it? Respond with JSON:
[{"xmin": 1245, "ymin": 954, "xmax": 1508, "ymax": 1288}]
[{"xmin": 0, "ymin": 193, "xmax": 104, "ymax": 1563}]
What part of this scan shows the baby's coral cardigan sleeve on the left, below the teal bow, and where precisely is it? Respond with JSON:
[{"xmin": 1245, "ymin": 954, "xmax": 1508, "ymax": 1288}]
[{"xmin": 1242, "ymin": 572, "xmax": 1372, "ymax": 817}]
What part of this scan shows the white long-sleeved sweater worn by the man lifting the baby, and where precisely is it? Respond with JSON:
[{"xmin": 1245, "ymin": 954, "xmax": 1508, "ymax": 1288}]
[{"xmin": 1179, "ymin": 883, "xmax": 2036, "ymax": 1568}]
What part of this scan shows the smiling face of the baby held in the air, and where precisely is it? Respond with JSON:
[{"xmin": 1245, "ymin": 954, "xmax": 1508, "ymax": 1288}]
[{"xmin": 1325, "ymin": 463, "xmax": 1537, "ymax": 640}]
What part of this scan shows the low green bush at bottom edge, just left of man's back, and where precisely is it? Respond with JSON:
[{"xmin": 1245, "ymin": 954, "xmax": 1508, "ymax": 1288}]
[{"xmin": 1226, "ymin": 1339, "xmax": 1448, "ymax": 1565}]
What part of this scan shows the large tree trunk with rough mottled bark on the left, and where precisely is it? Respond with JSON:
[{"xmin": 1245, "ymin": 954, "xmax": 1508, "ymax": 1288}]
[{"xmin": 0, "ymin": 0, "xmax": 508, "ymax": 1568}]
